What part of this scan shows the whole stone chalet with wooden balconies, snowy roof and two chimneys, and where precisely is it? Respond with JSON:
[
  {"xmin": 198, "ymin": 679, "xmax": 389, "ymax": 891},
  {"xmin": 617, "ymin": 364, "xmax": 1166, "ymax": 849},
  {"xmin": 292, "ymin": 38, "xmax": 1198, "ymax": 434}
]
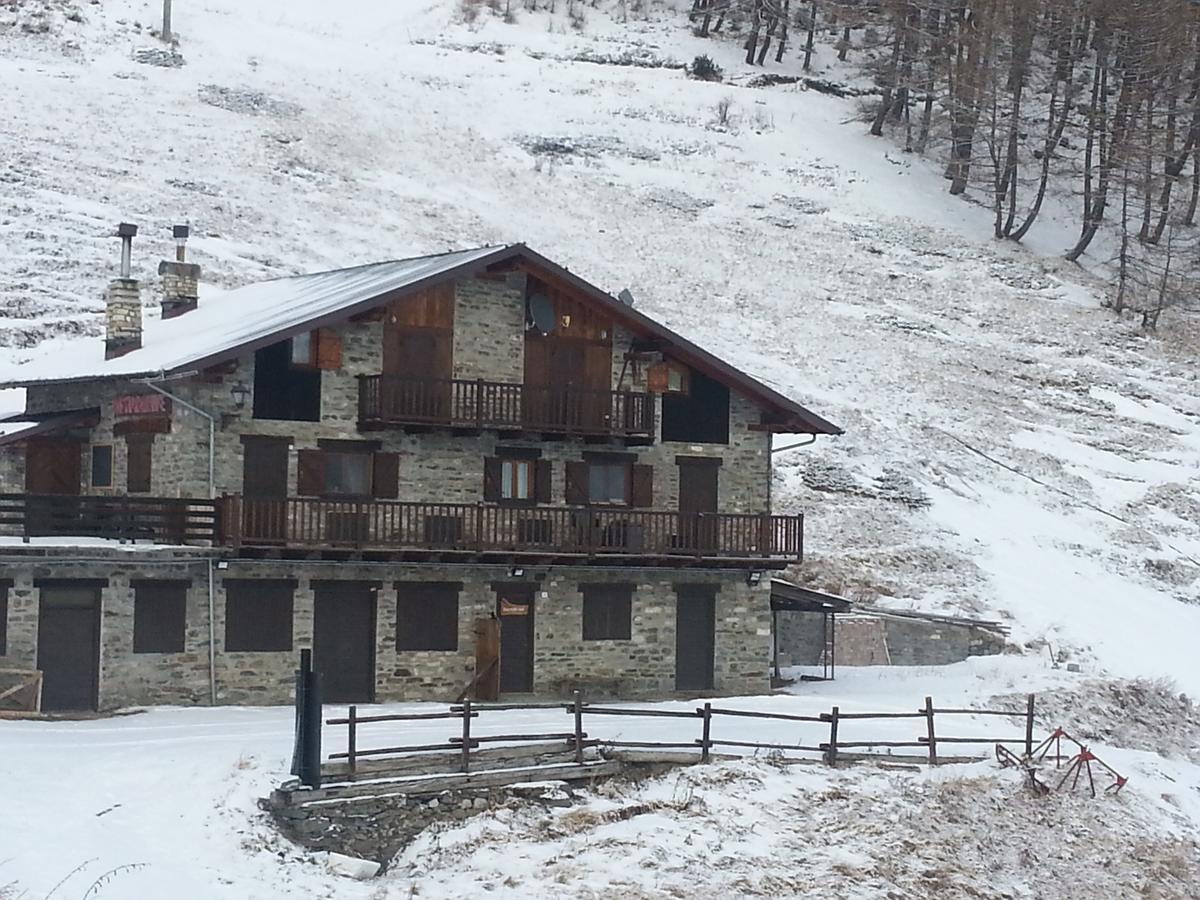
[{"xmin": 0, "ymin": 232, "xmax": 839, "ymax": 710}]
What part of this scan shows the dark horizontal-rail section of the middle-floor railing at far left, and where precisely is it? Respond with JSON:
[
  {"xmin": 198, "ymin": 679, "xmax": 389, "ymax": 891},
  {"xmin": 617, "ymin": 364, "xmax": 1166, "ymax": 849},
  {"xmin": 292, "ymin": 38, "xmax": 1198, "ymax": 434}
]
[{"xmin": 0, "ymin": 494, "xmax": 221, "ymax": 544}]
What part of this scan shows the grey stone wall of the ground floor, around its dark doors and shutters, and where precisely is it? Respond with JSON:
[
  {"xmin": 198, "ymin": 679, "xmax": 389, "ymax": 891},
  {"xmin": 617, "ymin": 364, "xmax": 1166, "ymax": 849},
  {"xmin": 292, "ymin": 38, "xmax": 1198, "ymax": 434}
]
[{"xmin": 0, "ymin": 550, "xmax": 770, "ymax": 709}]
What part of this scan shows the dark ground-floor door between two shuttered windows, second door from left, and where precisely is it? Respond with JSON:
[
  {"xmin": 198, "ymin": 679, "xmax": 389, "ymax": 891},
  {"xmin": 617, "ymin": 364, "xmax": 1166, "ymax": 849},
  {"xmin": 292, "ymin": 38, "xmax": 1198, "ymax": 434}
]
[{"xmin": 312, "ymin": 581, "xmax": 376, "ymax": 703}]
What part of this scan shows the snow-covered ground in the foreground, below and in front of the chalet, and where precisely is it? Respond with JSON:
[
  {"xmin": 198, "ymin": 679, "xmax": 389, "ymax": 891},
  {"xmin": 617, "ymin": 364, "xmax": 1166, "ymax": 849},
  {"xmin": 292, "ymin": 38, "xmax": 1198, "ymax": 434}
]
[{"xmin": 0, "ymin": 658, "xmax": 1200, "ymax": 900}]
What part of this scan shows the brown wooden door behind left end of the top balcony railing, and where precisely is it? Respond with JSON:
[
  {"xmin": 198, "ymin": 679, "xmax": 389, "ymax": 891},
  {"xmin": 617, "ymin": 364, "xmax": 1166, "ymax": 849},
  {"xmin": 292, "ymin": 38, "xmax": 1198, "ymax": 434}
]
[{"xmin": 379, "ymin": 328, "xmax": 454, "ymax": 422}]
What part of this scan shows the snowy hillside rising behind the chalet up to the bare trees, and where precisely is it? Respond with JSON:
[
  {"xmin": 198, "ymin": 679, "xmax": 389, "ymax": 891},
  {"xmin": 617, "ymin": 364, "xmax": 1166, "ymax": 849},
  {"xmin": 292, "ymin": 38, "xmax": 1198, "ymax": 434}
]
[{"xmin": 0, "ymin": 0, "xmax": 1200, "ymax": 692}]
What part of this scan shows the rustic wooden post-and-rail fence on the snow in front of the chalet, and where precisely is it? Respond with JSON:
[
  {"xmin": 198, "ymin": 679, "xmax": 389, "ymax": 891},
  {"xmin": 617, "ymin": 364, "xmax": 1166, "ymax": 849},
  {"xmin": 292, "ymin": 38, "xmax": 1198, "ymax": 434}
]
[{"xmin": 325, "ymin": 691, "xmax": 1034, "ymax": 779}]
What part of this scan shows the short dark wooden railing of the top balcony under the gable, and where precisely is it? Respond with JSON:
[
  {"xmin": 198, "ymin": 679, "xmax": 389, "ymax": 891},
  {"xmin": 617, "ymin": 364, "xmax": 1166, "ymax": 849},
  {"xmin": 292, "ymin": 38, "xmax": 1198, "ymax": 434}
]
[{"xmin": 359, "ymin": 374, "xmax": 654, "ymax": 438}]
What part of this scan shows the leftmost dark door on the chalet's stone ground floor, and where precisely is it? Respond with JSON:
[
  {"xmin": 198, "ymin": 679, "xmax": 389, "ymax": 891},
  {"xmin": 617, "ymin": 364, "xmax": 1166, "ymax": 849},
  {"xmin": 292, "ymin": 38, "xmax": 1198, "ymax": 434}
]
[{"xmin": 37, "ymin": 582, "xmax": 101, "ymax": 710}]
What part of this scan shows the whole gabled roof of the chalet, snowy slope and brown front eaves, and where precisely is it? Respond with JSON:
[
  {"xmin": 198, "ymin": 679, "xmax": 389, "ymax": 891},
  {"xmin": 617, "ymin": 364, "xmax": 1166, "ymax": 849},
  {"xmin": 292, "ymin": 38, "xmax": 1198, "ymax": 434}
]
[{"xmin": 0, "ymin": 244, "xmax": 841, "ymax": 434}]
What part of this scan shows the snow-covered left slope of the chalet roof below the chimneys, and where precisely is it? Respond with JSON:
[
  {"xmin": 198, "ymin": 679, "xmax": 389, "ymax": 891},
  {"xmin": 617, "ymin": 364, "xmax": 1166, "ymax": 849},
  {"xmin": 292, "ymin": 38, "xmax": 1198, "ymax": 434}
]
[{"xmin": 0, "ymin": 246, "xmax": 506, "ymax": 385}]
